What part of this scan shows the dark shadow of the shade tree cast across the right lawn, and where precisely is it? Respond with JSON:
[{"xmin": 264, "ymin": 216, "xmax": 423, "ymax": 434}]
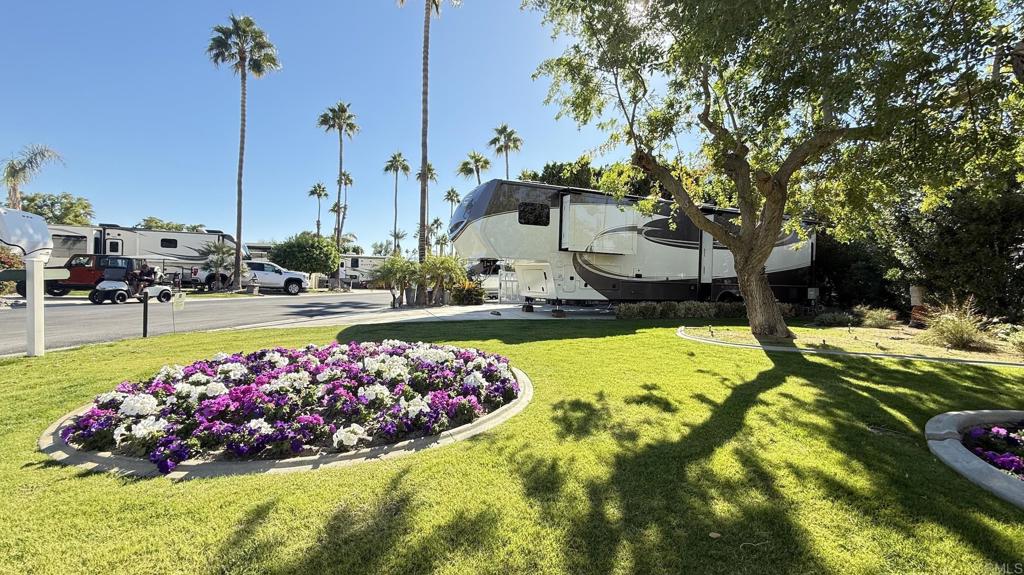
[{"xmin": 515, "ymin": 353, "xmax": 1022, "ymax": 574}]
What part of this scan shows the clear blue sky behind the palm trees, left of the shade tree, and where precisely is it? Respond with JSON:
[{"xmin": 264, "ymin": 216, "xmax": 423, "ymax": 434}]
[{"xmin": 0, "ymin": 0, "xmax": 615, "ymax": 248}]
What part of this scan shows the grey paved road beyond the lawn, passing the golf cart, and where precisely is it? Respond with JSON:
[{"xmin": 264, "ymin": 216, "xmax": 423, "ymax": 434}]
[{"xmin": 0, "ymin": 290, "xmax": 391, "ymax": 355}]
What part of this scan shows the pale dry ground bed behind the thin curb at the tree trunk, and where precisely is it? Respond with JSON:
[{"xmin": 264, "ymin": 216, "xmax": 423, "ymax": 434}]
[{"xmin": 686, "ymin": 323, "xmax": 1024, "ymax": 363}]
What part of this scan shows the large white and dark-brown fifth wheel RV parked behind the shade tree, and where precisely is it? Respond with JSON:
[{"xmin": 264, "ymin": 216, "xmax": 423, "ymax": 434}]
[{"xmin": 449, "ymin": 180, "xmax": 815, "ymax": 304}]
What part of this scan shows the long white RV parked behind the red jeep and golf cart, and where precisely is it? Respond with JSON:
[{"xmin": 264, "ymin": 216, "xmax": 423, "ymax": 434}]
[{"xmin": 49, "ymin": 224, "xmax": 251, "ymax": 285}]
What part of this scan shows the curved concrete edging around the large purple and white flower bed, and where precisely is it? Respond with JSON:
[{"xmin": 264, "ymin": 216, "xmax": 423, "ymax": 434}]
[{"xmin": 38, "ymin": 367, "xmax": 534, "ymax": 480}]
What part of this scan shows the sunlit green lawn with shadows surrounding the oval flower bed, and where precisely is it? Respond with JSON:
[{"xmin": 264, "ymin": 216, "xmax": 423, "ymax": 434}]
[{"xmin": 0, "ymin": 320, "xmax": 1024, "ymax": 575}]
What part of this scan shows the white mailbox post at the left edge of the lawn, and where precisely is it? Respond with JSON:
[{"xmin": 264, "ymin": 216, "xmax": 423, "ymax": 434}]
[{"xmin": 0, "ymin": 208, "xmax": 53, "ymax": 356}]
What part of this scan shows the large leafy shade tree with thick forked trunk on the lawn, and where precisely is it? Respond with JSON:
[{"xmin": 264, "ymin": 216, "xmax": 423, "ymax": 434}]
[{"xmin": 527, "ymin": 0, "xmax": 1019, "ymax": 336}]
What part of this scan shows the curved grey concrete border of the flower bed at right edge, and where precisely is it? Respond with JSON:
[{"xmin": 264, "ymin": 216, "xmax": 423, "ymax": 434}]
[{"xmin": 925, "ymin": 409, "xmax": 1024, "ymax": 508}]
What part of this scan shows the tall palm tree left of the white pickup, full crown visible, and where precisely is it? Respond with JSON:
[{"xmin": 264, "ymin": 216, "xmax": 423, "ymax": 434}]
[{"xmin": 206, "ymin": 14, "xmax": 281, "ymax": 290}]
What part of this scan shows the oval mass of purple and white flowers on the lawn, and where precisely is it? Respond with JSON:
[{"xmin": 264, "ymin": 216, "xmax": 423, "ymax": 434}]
[{"xmin": 60, "ymin": 340, "xmax": 519, "ymax": 474}]
